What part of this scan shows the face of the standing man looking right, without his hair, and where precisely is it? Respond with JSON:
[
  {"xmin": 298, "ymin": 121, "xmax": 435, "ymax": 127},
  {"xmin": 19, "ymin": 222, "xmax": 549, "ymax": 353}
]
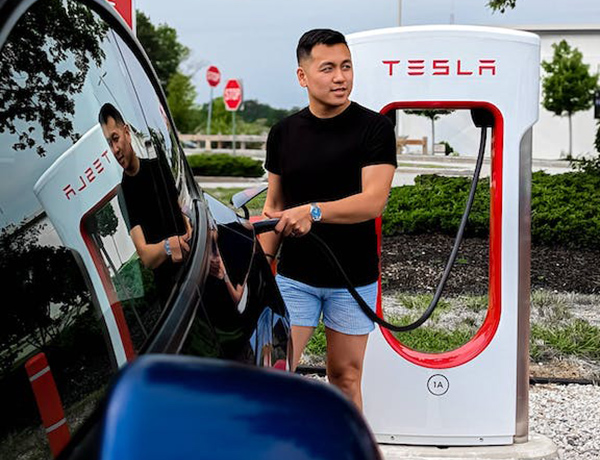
[{"xmin": 297, "ymin": 43, "xmax": 354, "ymax": 111}]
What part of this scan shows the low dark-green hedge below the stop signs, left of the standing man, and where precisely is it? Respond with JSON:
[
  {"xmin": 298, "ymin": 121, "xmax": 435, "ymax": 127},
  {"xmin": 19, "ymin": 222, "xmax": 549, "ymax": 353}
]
[{"xmin": 187, "ymin": 153, "xmax": 265, "ymax": 177}]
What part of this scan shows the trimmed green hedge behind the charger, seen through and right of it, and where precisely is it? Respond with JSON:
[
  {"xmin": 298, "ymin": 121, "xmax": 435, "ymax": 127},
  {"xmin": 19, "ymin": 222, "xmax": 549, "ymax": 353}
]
[{"xmin": 383, "ymin": 171, "xmax": 600, "ymax": 248}]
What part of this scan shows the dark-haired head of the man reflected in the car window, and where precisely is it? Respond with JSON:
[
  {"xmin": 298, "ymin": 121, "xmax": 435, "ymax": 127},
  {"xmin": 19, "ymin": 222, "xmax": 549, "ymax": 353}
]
[{"xmin": 98, "ymin": 103, "xmax": 139, "ymax": 175}]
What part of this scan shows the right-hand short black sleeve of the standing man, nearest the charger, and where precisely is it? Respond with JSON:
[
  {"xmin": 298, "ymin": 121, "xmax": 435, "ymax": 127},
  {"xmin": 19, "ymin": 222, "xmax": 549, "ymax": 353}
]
[{"xmin": 361, "ymin": 114, "xmax": 398, "ymax": 167}]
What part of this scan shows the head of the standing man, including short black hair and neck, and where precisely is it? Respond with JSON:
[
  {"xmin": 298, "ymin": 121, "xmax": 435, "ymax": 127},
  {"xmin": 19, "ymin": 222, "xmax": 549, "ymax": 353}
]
[{"xmin": 296, "ymin": 29, "xmax": 354, "ymax": 116}]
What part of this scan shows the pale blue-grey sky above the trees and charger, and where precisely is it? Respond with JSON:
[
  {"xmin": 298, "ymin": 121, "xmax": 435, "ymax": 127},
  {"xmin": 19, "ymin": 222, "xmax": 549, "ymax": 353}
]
[{"xmin": 134, "ymin": 0, "xmax": 600, "ymax": 109}]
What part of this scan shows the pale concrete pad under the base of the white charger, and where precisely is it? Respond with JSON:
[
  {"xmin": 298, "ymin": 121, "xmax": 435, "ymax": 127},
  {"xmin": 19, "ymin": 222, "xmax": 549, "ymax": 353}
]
[{"xmin": 379, "ymin": 433, "xmax": 559, "ymax": 460}]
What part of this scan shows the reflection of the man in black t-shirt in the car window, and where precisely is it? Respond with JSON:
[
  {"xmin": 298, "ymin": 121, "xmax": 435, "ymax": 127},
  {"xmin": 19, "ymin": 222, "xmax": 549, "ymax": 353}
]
[{"xmin": 98, "ymin": 103, "xmax": 191, "ymax": 302}]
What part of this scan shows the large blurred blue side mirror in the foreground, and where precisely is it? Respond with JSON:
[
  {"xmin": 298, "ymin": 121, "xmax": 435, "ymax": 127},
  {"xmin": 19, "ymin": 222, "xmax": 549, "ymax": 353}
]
[{"xmin": 101, "ymin": 355, "xmax": 381, "ymax": 460}]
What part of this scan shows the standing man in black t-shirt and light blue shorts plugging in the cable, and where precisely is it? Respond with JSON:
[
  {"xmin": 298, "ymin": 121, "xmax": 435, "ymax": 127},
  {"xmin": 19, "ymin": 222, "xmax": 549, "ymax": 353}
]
[{"xmin": 261, "ymin": 29, "xmax": 396, "ymax": 408}]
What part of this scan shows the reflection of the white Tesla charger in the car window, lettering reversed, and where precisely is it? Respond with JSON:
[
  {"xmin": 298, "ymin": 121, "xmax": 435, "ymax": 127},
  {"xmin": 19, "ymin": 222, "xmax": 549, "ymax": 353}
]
[{"xmin": 33, "ymin": 124, "xmax": 134, "ymax": 366}]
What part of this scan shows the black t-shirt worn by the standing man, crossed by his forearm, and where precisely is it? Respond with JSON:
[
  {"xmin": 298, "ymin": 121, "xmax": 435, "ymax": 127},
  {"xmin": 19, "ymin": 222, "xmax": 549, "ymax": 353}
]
[{"xmin": 265, "ymin": 102, "xmax": 396, "ymax": 287}]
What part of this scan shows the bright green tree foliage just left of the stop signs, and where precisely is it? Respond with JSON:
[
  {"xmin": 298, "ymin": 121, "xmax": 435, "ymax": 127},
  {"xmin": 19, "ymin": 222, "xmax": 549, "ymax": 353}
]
[{"xmin": 167, "ymin": 72, "xmax": 201, "ymax": 133}]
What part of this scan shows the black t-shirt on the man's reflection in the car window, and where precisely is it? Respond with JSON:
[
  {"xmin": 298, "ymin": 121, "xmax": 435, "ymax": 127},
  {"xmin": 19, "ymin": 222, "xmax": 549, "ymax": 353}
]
[{"xmin": 121, "ymin": 158, "xmax": 186, "ymax": 300}]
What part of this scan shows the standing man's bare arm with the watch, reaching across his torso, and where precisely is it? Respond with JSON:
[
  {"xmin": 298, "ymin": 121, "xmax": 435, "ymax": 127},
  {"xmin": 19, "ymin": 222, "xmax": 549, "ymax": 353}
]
[{"xmin": 263, "ymin": 164, "xmax": 396, "ymax": 237}]
